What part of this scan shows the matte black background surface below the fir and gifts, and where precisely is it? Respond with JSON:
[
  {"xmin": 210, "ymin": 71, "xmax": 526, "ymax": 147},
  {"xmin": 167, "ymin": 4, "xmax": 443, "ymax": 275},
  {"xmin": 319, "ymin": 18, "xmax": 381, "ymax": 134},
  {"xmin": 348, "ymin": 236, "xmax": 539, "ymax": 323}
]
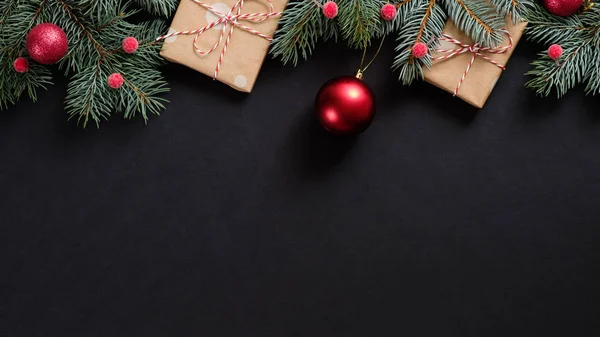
[{"xmin": 0, "ymin": 37, "xmax": 600, "ymax": 337}]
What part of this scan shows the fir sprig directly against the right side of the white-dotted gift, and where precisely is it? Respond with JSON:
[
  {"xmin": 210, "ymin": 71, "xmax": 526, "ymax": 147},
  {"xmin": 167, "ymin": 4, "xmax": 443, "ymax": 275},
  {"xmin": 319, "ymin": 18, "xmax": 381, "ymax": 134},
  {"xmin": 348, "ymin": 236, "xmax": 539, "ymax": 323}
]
[{"xmin": 271, "ymin": 0, "xmax": 337, "ymax": 65}]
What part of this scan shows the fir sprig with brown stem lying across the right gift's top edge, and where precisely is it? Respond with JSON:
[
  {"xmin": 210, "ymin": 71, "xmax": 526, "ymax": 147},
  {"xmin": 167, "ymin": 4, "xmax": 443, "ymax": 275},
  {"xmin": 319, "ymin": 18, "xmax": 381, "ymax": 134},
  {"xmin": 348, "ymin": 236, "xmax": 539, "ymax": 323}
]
[{"xmin": 442, "ymin": 0, "xmax": 504, "ymax": 47}]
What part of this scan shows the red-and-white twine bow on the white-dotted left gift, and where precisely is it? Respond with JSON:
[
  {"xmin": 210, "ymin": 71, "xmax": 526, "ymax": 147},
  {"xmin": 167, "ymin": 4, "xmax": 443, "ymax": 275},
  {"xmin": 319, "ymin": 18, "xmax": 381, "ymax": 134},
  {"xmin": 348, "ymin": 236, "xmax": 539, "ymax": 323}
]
[{"xmin": 156, "ymin": 0, "xmax": 281, "ymax": 79}]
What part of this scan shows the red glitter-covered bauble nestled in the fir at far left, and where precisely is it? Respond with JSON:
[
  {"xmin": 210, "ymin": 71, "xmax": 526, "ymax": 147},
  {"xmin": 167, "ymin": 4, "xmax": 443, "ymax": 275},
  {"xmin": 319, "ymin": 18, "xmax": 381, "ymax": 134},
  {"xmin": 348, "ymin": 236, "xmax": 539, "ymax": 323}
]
[{"xmin": 27, "ymin": 23, "xmax": 69, "ymax": 64}]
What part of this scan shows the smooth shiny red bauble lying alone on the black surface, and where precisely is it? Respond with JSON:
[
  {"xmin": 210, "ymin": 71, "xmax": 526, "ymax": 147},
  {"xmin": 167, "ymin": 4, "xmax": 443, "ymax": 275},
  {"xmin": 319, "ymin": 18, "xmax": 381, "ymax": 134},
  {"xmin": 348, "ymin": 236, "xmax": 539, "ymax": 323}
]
[{"xmin": 315, "ymin": 76, "xmax": 375, "ymax": 135}]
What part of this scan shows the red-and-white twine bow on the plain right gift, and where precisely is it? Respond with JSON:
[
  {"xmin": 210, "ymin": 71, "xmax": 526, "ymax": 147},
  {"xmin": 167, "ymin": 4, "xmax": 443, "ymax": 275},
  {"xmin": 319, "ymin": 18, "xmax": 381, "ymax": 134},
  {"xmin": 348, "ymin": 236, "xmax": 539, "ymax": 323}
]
[{"xmin": 432, "ymin": 29, "xmax": 513, "ymax": 96}]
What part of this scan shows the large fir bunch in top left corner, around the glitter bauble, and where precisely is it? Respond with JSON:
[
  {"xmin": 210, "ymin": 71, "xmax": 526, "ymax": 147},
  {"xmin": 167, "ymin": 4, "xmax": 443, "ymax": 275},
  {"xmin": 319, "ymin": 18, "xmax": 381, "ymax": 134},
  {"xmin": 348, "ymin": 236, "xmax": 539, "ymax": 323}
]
[{"xmin": 0, "ymin": 0, "xmax": 176, "ymax": 127}]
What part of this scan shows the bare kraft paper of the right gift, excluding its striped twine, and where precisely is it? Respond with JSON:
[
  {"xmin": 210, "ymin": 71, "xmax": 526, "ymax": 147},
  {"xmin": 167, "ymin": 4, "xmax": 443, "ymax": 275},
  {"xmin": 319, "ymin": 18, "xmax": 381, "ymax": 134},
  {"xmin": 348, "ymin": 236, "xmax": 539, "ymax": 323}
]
[{"xmin": 423, "ymin": 18, "xmax": 527, "ymax": 108}]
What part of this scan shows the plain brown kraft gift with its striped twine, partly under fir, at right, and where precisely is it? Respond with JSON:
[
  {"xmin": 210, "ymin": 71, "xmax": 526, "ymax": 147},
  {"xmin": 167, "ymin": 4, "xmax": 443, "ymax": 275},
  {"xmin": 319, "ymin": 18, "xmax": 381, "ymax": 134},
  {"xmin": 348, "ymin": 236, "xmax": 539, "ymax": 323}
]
[{"xmin": 424, "ymin": 18, "xmax": 527, "ymax": 108}]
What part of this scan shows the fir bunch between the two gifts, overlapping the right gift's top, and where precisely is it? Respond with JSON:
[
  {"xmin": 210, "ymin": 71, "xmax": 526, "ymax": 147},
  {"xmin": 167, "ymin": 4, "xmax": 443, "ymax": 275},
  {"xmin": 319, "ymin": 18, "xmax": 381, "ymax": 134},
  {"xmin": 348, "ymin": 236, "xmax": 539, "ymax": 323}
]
[{"xmin": 271, "ymin": 0, "xmax": 531, "ymax": 84}]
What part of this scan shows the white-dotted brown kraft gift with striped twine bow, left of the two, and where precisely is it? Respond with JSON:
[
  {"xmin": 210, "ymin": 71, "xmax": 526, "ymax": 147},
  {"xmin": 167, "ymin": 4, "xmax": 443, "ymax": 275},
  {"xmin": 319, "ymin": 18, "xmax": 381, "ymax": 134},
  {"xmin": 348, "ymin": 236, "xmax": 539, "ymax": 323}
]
[{"xmin": 161, "ymin": 0, "xmax": 287, "ymax": 92}]
